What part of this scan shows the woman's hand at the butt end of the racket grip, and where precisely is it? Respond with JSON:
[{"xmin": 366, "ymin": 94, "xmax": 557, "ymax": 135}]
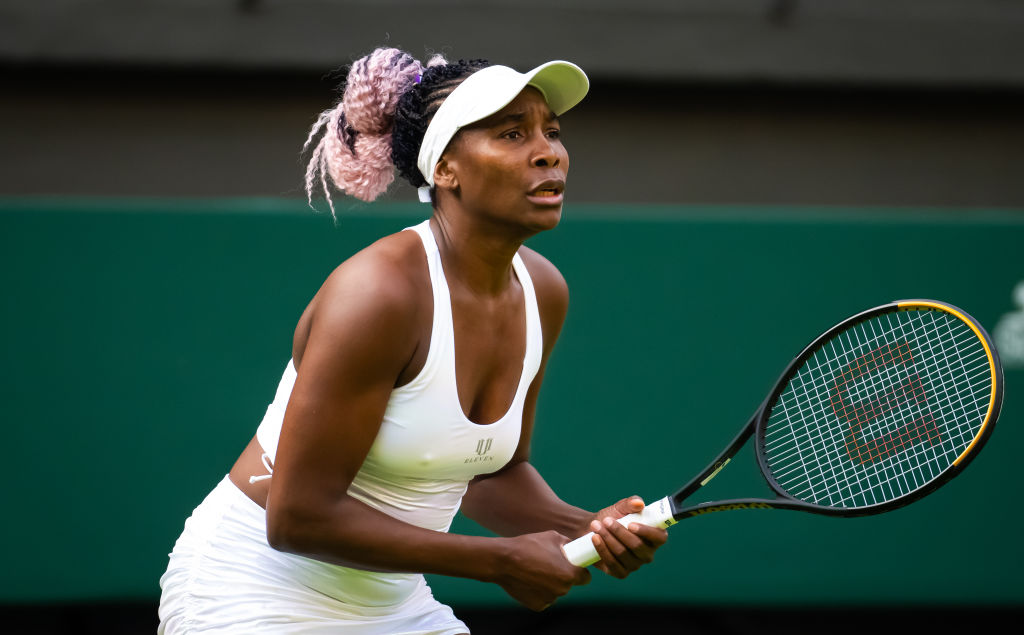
[{"xmin": 495, "ymin": 532, "xmax": 590, "ymax": 610}]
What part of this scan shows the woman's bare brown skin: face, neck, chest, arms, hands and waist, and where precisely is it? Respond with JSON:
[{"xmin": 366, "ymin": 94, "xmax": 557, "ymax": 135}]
[{"xmin": 229, "ymin": 88, "xmax": 667, "ymax": 610}]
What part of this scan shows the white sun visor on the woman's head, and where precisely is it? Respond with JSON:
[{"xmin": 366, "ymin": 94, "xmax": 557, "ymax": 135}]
[{"xmin": 416, "ymin": 61, "xmax": 590, "ymax": 203}]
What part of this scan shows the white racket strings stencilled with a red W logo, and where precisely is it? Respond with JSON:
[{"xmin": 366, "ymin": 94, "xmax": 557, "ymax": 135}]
[{"xmin": 765, "ymin": 310, "xmax": 991, "ymax": 507}]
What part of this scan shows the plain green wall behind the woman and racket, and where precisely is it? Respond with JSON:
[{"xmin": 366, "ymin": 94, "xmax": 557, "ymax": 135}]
[{"xmin": 0, "ymin": 199, "xmax": 1024, "ymax": 605}]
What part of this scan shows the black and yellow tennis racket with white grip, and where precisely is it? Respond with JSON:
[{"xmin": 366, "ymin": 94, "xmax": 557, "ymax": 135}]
[{"xmin": 563, "ymin": 300, "xmax": 1002, "ymax": 566}]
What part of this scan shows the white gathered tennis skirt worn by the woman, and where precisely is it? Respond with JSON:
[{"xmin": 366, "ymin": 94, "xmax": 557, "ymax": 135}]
[{"xmin": 157, "ymin": 476, "xmax": 469, "ymax": 635}]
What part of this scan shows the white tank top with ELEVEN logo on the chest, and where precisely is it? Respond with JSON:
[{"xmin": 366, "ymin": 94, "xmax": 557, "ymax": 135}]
[{"xmin": 256, "ymin": 221, "xmax": 543, "ymax": 532}]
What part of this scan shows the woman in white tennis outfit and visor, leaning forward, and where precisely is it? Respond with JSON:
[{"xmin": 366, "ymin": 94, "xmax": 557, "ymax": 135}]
[{"xmin": 160, "ymin": 49, "xmax": 667, "ymax": 635}]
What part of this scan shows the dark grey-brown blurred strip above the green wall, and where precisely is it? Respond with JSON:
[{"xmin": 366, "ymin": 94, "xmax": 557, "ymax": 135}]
[{"xmin": 0, "ymin": 0, "xmax": 1024, "ymax": 211}]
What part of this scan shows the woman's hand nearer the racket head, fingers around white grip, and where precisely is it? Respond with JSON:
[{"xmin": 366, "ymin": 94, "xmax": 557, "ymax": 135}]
[{"xmin": 589, "ymin": 496, "xmax": 669, "ymax": 579}]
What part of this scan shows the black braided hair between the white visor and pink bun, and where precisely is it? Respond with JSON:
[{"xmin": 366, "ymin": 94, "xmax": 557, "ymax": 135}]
[{"xmin": 391, "ymin": 59, "xmax": 490, "ymax": 187}]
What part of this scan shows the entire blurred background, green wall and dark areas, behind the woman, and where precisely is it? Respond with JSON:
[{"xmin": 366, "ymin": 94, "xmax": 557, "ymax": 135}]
[{"xmin": 0, "ymin": 0, "xmax": 1024, "ymax": 635}]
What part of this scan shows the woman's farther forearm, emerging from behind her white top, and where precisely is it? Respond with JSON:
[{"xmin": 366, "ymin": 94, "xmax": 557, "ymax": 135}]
[{"xmin": 462, "ymin": 461, "xmax": 594, "ymax": 538}]
